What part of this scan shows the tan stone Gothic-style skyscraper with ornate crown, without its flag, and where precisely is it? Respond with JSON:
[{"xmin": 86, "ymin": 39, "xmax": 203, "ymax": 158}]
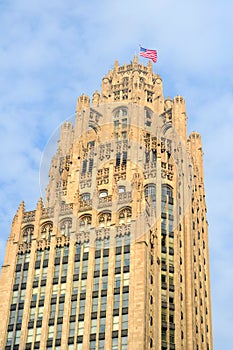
[{"xmin": 0, "ymin": 56, "xmax": 213, "ymax": 350}]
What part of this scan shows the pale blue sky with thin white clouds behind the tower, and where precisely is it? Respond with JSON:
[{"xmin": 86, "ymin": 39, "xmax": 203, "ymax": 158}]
[{"xmin": 0, "ymin": 0, "xmax": 233, "ymax": 350}]
